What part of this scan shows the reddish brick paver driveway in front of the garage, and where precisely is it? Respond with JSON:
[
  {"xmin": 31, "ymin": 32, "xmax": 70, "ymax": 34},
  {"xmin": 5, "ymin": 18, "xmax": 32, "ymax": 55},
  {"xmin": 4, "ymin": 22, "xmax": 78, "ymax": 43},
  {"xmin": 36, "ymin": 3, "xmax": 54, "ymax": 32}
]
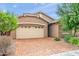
[{"xmin": 15, "ymin": 38, "xmax": 79, "ymax": 56}]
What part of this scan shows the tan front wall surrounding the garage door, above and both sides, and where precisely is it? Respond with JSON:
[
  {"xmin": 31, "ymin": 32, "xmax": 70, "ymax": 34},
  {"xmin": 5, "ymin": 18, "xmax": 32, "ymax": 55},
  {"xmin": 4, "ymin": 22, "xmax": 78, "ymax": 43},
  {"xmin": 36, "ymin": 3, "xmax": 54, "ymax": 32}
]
[{"xmin": 11, "ymin": 17, "xmax": 48, "ymax": 38}]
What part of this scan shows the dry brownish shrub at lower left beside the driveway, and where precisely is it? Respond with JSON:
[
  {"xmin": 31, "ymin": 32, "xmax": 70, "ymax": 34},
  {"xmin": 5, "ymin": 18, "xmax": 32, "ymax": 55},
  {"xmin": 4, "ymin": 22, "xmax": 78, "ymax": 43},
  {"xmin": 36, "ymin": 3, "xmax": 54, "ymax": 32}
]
[{"xmin": 0, "ymin": 36, "xmax": 13, "ymax": 56}]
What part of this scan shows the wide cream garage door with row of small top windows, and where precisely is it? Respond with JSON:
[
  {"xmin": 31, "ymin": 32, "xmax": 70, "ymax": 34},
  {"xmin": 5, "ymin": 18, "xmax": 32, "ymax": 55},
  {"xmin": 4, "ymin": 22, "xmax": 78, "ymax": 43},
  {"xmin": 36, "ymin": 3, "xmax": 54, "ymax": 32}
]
[{"xmin": 16, "ymin": 26, "xmax": 44, "ymax": 39}]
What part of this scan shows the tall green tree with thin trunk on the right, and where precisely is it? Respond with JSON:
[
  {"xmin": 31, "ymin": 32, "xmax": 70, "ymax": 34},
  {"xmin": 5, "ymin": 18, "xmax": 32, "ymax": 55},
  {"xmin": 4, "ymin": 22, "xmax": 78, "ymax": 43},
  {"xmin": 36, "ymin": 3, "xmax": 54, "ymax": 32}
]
[{"xmin": 58, "ymin": 3, "xmax": 79, "ymax": 36}]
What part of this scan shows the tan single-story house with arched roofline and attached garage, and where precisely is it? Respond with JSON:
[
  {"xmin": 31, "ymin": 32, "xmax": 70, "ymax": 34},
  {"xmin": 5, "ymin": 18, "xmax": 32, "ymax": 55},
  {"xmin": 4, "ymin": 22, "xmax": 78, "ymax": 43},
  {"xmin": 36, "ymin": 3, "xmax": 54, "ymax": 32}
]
[{"xmin": 11, "ymin": 12, "xmax": 60, "ymax": 39}]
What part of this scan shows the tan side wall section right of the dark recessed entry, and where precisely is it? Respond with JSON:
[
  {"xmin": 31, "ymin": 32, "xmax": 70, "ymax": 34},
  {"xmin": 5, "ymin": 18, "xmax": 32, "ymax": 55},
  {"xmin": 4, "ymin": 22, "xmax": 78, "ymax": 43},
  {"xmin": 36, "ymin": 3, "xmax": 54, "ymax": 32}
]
[{"xmin": 49, "ymin": 23, "xmax": 60, "ymax": 37}]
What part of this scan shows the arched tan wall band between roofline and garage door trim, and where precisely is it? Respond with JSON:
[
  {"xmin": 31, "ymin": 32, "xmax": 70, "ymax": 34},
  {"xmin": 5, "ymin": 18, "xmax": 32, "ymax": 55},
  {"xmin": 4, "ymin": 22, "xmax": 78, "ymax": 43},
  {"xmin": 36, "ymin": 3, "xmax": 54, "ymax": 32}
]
[{"xmin": 19, "ymin": 16, "xmax": 48, "ymax": 26}]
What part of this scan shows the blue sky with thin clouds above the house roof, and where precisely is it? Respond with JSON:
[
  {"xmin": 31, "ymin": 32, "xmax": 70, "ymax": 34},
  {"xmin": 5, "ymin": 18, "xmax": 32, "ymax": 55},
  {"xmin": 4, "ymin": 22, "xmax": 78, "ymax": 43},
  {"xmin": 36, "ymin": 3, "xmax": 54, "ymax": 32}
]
[{"xmin": 0, "ymin": 3, "xmax": 59, "ymax": 19}]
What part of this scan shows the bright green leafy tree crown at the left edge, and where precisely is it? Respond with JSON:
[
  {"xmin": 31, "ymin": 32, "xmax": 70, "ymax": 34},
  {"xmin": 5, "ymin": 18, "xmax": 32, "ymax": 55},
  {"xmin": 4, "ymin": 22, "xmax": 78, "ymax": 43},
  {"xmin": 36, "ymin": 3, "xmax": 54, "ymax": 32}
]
[{"xmin": 0, "ymin": 12, "xmax": 18, "ymax": 32}]
